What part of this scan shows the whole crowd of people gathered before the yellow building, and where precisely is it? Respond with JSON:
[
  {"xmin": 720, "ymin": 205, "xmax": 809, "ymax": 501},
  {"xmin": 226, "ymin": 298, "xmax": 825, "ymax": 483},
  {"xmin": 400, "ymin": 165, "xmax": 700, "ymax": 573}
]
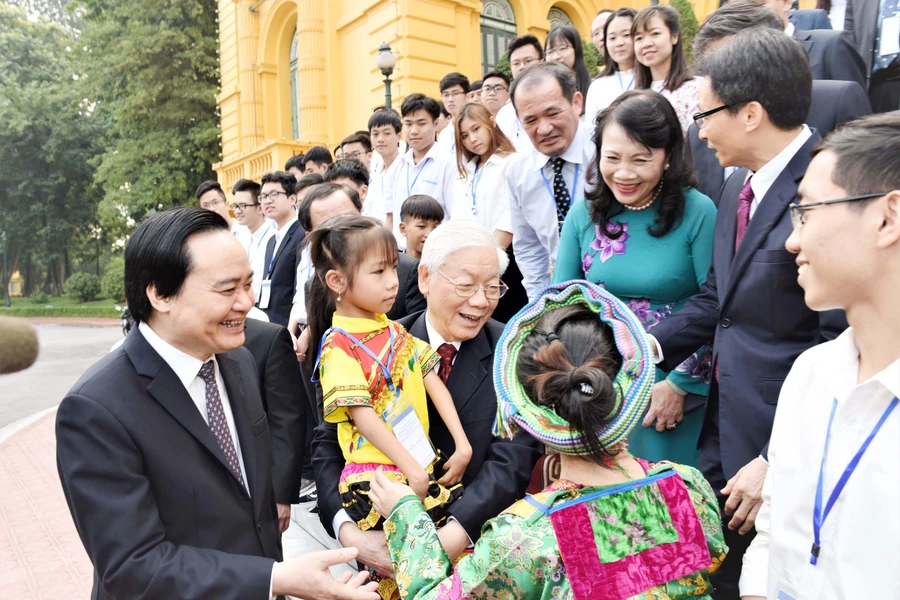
[{"xmin": 57, "ymin": 0, "xmax": 900, "ymax": 600}]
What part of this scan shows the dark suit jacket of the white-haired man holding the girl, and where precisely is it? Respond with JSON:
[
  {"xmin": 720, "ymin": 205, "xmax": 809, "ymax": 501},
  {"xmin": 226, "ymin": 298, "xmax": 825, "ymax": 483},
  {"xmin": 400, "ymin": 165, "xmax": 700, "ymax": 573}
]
[{"xmin": 313, "ymin": 312, "xmax": 543, "ymax": 541}]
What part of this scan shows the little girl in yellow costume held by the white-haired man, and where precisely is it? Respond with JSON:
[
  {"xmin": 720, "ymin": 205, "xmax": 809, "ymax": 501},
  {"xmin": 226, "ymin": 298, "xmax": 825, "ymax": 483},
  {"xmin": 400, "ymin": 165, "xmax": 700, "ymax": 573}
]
[{"xmin": 308, "ymin": 215, "xmax": 472, "ymax": 592}]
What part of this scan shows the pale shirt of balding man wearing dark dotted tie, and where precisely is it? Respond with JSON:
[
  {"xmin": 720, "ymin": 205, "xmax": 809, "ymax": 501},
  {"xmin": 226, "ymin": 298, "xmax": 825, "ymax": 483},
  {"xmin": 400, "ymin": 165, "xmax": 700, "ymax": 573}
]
[{"xmin": 506, "ymin": 125, "xmax": 596, "ymax": 300}]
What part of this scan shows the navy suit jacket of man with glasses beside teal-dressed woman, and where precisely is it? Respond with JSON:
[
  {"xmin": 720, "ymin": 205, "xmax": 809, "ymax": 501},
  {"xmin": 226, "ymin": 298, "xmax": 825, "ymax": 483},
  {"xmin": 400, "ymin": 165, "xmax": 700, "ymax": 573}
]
[{"xmin": 653, "ymin": 132, "xmax": 847, "ymax": 479}]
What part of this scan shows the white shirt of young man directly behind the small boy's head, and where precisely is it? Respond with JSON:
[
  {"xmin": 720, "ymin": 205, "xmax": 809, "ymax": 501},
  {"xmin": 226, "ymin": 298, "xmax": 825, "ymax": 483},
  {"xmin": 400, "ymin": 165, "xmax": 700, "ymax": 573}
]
[{"xmin": 384, "ymin": 144, "xmax": 458, "ymax": 250}]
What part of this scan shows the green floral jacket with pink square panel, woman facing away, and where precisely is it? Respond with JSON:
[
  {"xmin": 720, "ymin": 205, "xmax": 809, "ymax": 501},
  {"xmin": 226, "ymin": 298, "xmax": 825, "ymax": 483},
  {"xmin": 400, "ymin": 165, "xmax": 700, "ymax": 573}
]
[{"xmin": 384, "ymin": 461, "xmax": 727, "ymax": 600}]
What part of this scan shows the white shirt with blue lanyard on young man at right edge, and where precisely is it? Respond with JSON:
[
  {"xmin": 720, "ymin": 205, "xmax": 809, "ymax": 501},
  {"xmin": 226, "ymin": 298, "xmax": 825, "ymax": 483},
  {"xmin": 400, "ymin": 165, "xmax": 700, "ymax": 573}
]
[{"xmin": 740, "ymin": 328, "xmax": 900, "ymax": 600}]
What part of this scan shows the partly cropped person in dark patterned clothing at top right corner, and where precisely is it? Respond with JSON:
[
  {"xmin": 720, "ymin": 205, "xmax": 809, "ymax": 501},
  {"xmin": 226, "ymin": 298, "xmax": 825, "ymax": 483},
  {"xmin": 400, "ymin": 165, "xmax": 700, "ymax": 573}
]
[{"xmin": 844, "ymin": 0, "xmax": 900, "ymax": 113}]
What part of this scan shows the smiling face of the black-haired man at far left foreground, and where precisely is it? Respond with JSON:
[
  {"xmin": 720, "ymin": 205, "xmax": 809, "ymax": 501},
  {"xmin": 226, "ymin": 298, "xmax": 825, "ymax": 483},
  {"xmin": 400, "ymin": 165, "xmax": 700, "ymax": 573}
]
[{"xmin": 147, "ymin": 230, "xmax": 254, "ymax": 360}]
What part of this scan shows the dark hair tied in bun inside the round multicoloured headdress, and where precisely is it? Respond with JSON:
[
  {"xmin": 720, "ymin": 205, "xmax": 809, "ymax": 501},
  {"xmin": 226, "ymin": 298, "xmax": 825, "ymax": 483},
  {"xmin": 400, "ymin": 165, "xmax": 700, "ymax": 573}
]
[{"xmin": 516, "ymin": 304, "xmax": 622, "ymax": 465}]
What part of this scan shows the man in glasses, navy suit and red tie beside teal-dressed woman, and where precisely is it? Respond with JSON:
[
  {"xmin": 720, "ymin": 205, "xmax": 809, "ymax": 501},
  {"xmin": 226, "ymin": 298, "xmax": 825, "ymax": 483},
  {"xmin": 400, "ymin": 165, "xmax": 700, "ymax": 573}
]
[{"xmin": 650, "ymin": 28, "xmax": 846, "ymax": 600}]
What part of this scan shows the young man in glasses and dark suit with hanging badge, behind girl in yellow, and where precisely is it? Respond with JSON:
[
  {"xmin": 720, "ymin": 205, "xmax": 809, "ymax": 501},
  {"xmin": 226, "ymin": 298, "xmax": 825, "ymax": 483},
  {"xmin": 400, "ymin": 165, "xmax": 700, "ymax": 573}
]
[{"xmin": 254, "ymin": 171, "xmax": 306, "ymax": 325}]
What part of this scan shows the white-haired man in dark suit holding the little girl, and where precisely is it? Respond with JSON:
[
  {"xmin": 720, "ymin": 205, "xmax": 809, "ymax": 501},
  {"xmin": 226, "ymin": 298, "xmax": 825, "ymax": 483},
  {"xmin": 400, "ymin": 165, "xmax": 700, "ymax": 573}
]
[{"xmin": 313, "ymin": 221, "xmax": 541, "ymax": 576}]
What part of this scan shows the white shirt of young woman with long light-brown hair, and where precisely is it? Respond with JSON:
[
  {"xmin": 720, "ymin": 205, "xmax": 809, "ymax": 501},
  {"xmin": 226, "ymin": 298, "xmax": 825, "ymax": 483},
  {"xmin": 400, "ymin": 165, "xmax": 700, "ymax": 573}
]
[{"xmin": 453, "ymin": 153, "xmax": 515, "ymax": 233}]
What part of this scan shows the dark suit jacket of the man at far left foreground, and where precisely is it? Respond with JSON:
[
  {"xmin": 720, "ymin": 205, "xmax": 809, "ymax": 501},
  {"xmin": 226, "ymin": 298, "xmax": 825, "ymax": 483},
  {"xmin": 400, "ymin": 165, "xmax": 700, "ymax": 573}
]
[{"xmin": 56, "ymin": 327, "xmax": 281, "ymax": 600}]
